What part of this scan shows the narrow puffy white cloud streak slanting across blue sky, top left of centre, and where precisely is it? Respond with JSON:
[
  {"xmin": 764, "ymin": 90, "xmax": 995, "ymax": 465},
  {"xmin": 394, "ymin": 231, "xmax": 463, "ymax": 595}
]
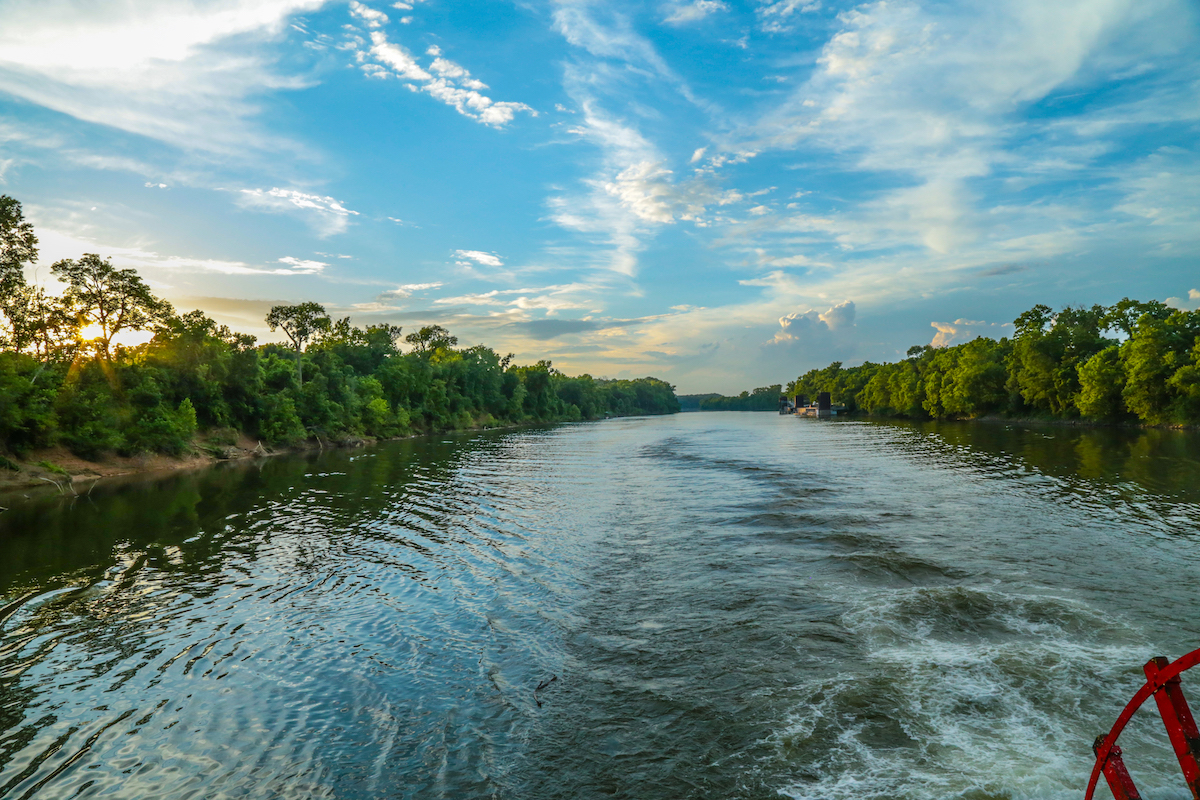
[{"xmin": 359, "ymin": 30, "xmax": 538, "ymax": 127}]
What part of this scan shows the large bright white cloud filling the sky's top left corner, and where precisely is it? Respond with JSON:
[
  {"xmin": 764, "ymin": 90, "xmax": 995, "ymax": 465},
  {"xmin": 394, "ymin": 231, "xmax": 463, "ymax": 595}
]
[{"xmin": 0, "ymin": 0, "xmax": 325, "ymax": 157}]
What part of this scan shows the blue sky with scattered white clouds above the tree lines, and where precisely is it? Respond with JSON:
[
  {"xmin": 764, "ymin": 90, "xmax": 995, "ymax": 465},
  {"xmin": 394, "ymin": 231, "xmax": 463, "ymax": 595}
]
[{"xmin": 0, "ymin": 0, "xmax": 1200, "ymax": 393}]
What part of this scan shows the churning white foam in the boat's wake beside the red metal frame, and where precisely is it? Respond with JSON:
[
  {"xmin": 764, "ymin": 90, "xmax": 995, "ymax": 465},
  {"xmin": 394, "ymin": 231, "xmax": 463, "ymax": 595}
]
[{"xmin": 774, "ymin": 587, "xmax": 1189, "ymax": 800}]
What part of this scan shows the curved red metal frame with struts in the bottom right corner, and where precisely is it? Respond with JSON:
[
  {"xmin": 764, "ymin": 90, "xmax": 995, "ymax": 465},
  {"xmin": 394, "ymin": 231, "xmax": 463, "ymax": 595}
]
[{"xmin": 1084, "ymin": 650, "xmax": 1200, "ymax": 800}]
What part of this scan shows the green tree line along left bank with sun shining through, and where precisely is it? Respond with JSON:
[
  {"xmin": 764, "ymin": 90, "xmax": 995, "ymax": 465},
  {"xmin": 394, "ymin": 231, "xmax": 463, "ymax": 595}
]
[{"xmin": 0, "ymin": 196, "xmax": 679, "ymax": 457}]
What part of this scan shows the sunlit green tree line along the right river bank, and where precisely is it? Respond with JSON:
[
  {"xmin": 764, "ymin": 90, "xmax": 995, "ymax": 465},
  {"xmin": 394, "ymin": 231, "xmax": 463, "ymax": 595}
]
[{"xmin": 786, "ymin": 297, "xmax": 1200, "ymax": 425}]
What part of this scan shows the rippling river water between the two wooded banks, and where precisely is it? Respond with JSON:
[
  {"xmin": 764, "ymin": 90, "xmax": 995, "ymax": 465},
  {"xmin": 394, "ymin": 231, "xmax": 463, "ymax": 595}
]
[{"xmin": 0, "ymin": 413, "xmax": 1200, "ymax": 800}]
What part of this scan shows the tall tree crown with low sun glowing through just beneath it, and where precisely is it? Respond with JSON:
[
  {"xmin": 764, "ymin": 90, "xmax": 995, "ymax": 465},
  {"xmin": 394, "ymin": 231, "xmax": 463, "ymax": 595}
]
[{"xmin": 50, "ymin": 253, "xmax": 174, "ymax": 361}]
